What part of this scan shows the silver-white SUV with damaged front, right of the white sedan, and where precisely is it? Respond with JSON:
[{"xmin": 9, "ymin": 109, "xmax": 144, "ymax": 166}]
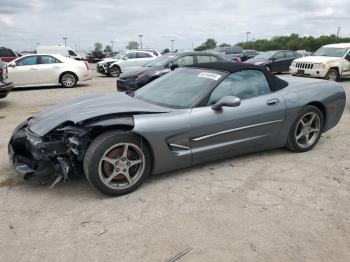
[{"xmin": 97, "ymin": 50, "xmax": 158, "ymax": 77}]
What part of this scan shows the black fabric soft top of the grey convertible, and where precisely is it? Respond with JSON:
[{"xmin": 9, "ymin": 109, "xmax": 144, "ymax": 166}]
[{"xmin": 186, "ymin": 62, "xmax": 288, "ymax": 91}]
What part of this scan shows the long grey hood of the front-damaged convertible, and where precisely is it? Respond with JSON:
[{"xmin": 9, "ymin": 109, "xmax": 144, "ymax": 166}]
[{"xmin": 29, "ymin": 92, "xmax": 173, "ymax": 136}]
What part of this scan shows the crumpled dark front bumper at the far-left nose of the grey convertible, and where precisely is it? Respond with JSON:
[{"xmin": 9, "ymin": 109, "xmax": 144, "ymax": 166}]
[{"xmin": 8, "ymin": 119, "xmax": 55, "ymax": 180}]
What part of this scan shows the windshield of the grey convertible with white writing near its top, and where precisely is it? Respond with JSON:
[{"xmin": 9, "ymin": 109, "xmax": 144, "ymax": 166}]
[{"xmin": 134, "ymin": 68, "xmax": 225, "ymax": 108}]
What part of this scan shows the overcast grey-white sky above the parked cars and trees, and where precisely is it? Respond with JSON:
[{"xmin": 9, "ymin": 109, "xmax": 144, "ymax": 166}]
[{"xmin": 0, "ymin": 0, "xmax": 350, "ymax": 51}]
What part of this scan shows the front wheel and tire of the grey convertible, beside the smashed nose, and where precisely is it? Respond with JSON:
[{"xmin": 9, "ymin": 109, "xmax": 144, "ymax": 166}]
[{"xmin": 83, "ymin": 131, "xmax": 152, "ymax": 196}]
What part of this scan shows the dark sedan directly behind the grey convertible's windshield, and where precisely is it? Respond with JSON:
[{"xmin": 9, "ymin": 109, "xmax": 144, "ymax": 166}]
[{"xmin": 117, "ymin": 52, "xmax": 225, "ymax": 91}]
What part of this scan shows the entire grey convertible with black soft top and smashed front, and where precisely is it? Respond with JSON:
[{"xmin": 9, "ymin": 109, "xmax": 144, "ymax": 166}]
[{"xmin": 9, "ymin": 62, "xmax": 345, "ymax": 195}]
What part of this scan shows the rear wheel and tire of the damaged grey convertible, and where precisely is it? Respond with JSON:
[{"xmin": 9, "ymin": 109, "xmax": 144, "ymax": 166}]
[{"xmin": 287, "ymin": 105, "xmax": 324, "ymax": 152}]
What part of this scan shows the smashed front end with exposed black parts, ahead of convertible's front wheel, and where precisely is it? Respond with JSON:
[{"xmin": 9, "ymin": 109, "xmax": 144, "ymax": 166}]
[{"xmin": 8, "ymin": 118, "xmax": 90, "ymax": 186}]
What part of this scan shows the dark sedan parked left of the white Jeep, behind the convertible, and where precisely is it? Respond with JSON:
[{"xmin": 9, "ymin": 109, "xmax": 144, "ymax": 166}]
[{"xmin": 245, "ymin": 50, "xmax": 301, "ymax": 73}]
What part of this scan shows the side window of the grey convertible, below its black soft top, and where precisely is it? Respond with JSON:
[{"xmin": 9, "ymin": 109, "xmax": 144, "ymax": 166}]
[{"xmin": 208, "ymin": 70, "xmax": 270, "ymax": 105}]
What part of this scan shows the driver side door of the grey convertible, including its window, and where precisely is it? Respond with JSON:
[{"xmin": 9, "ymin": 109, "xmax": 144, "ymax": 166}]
[{"xmin": 190, "ymin": 70, "xmax": 286, "ymax": 164}]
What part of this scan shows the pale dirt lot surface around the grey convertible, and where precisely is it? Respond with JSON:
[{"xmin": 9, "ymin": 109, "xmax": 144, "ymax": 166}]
[{"xmin": 0, "ymin": 66, "xmax": 350, "ymax": 261}]
